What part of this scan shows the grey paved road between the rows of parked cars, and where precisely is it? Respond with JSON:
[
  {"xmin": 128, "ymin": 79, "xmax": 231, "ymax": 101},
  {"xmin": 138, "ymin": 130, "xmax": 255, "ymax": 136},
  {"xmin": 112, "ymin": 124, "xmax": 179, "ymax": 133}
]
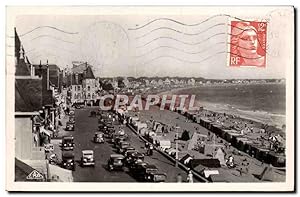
[{"xmin": 73, "ymin": 108, "xmax": 135, "ymax": 182}]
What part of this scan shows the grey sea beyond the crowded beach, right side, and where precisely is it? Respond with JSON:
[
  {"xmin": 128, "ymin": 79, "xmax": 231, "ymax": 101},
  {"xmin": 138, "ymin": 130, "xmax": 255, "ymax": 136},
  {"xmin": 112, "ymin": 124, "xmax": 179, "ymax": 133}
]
[{"xmin": 176, "ymin": 83, "xmax": 286, "ymax": 126}]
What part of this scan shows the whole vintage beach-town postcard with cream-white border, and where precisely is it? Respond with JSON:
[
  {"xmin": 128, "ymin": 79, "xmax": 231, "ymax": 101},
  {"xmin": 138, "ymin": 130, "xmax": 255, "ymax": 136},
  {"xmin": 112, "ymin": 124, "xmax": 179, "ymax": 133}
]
[{"xmin": 6, "ymin": 6, "xmax": 295, "ymax": 192}]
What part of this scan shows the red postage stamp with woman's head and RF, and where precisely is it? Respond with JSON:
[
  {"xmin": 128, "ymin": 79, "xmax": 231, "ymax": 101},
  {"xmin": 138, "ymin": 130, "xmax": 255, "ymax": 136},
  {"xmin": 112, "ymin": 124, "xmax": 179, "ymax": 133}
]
[{"xmin": 229, "ymin": 21, "xmax": 267, "ymax": 67}]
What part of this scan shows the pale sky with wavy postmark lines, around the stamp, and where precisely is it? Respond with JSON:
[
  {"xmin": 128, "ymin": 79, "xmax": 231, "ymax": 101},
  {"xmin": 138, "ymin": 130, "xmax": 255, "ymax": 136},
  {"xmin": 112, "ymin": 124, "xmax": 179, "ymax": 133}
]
[{"xmin": 7, "ymin": 8, "xmax": 293, "ymax": 79}]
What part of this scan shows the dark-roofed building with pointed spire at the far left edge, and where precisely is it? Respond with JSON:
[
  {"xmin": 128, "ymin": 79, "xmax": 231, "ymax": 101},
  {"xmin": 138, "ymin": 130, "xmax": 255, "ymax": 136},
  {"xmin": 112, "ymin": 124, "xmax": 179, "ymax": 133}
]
[{"xmin": 15, "ymin": 30, "xmax": 45, "ymax": 161}]
